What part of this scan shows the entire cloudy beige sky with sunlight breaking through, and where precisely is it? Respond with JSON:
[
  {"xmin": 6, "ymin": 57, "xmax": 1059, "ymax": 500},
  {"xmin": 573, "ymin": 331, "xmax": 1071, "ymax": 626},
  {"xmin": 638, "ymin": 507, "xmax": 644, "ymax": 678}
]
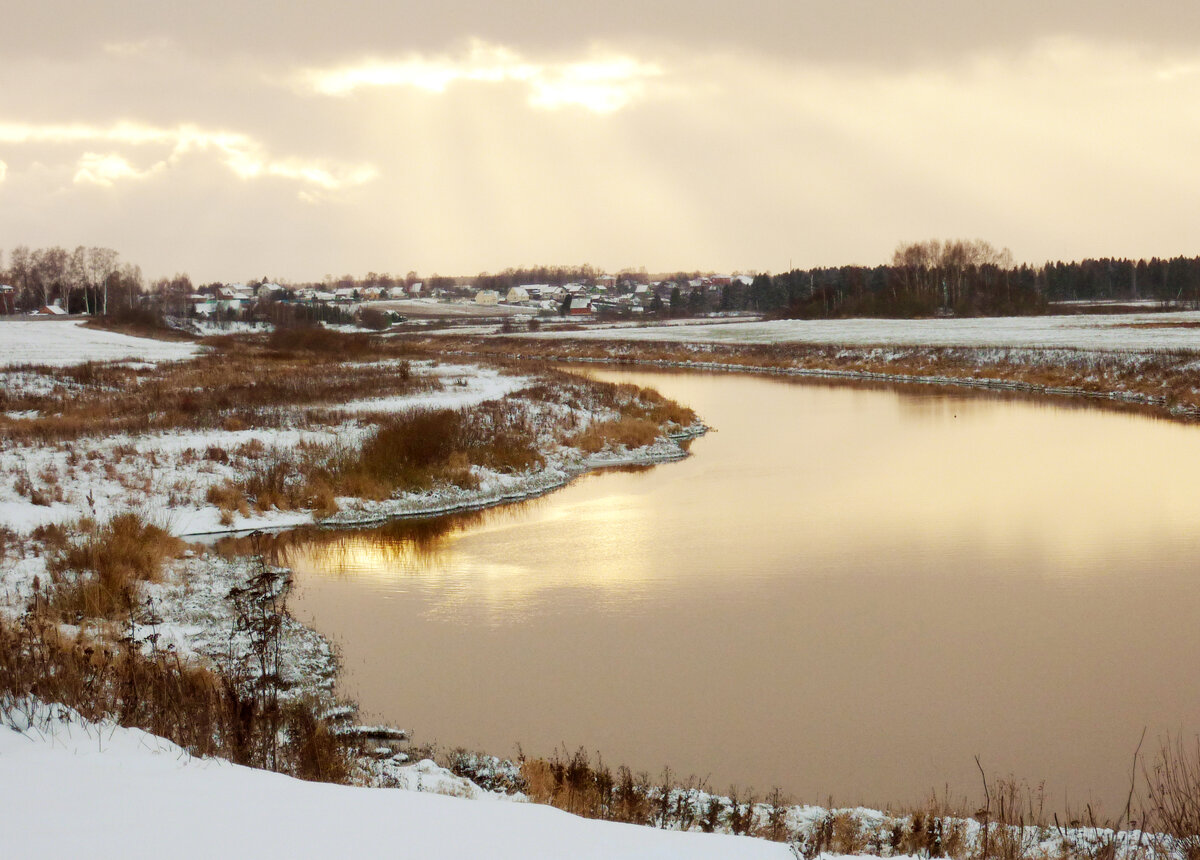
[{"xmin": 0, "ymin": 0, "xmax": 1200, "ymax": 281}]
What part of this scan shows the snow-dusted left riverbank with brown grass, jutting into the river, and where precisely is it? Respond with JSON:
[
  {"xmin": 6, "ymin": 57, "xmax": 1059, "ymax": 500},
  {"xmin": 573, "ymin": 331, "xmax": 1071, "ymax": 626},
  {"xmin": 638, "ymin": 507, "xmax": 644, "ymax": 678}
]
[{"xmin": 0, "ymin": 324, "xmax": 704, "ymax": 794}]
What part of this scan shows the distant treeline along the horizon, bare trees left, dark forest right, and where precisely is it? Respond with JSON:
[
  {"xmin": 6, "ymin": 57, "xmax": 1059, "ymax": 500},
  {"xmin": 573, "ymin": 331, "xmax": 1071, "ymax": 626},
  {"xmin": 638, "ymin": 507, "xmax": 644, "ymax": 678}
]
[{"xmin": 0, "ymin": 240, "xmax": 1200, "ymax": 318}]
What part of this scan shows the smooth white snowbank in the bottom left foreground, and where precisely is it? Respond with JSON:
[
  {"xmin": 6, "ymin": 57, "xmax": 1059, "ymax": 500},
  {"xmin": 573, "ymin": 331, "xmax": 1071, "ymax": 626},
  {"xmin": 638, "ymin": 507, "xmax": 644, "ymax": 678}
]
[{"xmin": 0, "ymin": 703, "xmax": 793, "ymax": 860}]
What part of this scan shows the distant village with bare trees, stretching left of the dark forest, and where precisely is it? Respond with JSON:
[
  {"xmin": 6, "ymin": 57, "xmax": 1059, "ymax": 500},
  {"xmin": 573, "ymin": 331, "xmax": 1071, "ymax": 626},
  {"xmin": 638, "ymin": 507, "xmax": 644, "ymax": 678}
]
[{"xmin": 0, "ymin": 246, "xmax": 761, "ymax": 329}]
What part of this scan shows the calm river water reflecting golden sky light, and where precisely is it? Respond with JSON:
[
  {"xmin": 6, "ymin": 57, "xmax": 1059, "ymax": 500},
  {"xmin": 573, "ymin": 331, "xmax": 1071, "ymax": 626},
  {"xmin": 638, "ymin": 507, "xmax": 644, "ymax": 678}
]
[{"xmin": 286, "ymin": 372, "xmax": 1200, "ymax": 812}]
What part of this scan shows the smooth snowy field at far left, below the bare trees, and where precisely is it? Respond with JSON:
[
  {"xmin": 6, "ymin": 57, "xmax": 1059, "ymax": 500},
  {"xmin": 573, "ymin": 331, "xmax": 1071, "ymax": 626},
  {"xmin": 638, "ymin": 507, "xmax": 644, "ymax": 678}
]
[{"xmin": 0, "ymin": 320, "xmax": 202, "ymax": 367}]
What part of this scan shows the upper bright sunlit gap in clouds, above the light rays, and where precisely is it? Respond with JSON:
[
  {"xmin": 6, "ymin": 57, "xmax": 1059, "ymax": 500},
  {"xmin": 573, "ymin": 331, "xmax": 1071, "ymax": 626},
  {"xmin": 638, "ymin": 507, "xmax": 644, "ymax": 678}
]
[{"xmin": 298, "ymin": 40, "xmax": 662, "ymax": 113}]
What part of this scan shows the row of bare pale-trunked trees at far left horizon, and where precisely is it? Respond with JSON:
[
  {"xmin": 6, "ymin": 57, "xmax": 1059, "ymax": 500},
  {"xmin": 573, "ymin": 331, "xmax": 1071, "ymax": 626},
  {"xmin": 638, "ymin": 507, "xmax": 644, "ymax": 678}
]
[{"xmin": 0, "ymin": 245, "xmax": 143, "ymax": 314}]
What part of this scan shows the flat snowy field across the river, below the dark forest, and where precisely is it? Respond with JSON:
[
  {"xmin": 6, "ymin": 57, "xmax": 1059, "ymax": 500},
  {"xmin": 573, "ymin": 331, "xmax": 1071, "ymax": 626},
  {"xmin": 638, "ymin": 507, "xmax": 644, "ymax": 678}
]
[{"xmin": 523, "ymin": 311, "xmax": 1200, "ymax": 351}]
